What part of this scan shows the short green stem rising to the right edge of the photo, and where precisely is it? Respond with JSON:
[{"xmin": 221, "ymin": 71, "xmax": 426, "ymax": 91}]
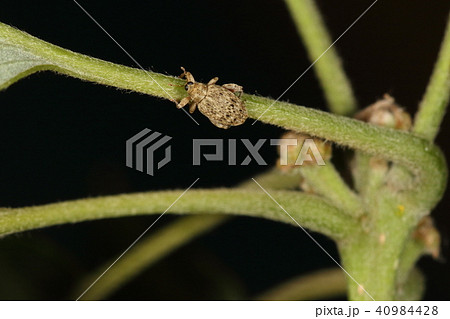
[{"xmin": 413, "ymin": 15, "xmax": 450, "ymax": 141}]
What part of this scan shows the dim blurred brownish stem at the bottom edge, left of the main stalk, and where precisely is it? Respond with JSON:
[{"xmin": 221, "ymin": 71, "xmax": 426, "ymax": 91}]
[{"xmin": 256, "ymin": 268, "xmax": 347, "ymax": 301}]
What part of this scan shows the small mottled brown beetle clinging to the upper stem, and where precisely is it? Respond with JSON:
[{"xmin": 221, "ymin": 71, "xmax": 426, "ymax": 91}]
[{"xmin": 177, "ymin": 67, "xmax": 248, "ymax": 129}]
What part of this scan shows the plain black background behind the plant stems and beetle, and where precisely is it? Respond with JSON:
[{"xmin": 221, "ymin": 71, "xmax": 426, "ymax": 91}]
[{"xmin": 0, "ymin": 0, "xmax": 450, "ymax": 300}]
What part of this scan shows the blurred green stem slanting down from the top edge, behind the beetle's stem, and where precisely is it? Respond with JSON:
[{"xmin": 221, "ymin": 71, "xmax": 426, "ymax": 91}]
[{"xmin": 285, "ymin": 0, "xmax": 357, "ymax": 115}]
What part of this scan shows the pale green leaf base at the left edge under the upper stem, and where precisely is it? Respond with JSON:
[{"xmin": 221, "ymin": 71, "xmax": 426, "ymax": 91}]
[{"xmin": 0, "ymin": 39, "xmax": 49, "ymax": 90}]
